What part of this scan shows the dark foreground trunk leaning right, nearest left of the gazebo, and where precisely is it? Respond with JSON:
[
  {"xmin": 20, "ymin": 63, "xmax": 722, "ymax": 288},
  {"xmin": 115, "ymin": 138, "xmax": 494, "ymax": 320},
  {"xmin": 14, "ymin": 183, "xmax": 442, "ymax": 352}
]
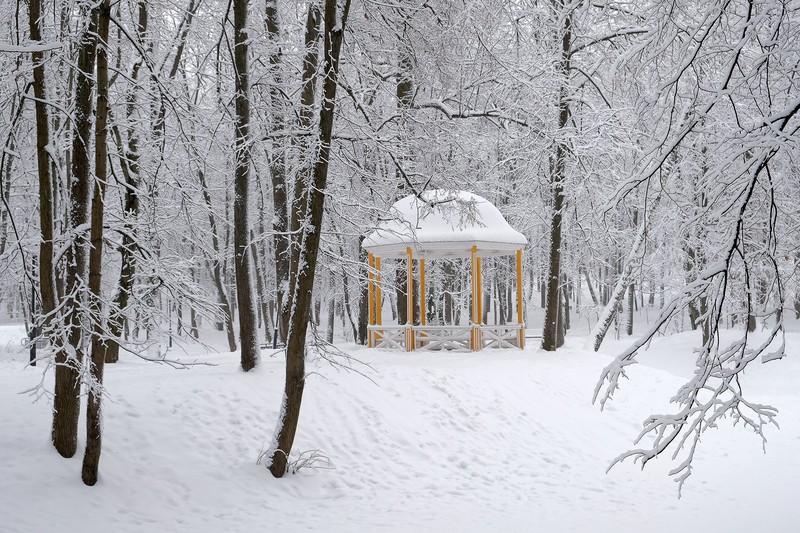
[{"xmin": 269, "ymin": 0, "xmax": 350, "ymax": 477}]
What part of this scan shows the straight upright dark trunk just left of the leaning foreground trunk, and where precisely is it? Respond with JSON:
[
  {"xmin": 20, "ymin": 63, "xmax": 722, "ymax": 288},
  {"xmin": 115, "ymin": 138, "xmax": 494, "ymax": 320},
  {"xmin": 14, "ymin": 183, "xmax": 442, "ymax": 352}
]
[{"xmin": 233, "ymin": 0, "xmax": 259, "ymax": 372}]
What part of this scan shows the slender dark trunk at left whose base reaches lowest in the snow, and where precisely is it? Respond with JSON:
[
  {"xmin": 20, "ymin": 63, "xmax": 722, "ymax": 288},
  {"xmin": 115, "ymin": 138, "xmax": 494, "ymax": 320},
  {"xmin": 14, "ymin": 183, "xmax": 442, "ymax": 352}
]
[{"xmin": 81, "ymin": 0, "xmax": 111, "ymax": 486}]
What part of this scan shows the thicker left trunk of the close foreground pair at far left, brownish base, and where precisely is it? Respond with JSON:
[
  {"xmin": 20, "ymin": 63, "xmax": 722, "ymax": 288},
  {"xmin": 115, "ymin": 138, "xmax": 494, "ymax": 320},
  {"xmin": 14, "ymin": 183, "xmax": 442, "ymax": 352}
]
[{"xmin": 52, "ymin": 6, "xmax": 99, "ymax": 457}]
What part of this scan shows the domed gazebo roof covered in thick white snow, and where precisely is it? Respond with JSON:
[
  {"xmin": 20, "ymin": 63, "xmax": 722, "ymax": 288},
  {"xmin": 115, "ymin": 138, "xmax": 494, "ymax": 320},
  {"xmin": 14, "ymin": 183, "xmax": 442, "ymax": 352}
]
[{"xmin": 362, "ymin": 189, "xmax": 528, "ymax": 259}]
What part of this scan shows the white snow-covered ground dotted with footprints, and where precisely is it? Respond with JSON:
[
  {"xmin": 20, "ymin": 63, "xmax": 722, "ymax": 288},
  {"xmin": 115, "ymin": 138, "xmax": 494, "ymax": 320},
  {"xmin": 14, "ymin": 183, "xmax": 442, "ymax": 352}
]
[{"xmin": 0, "ymin": 320, "xmax": 800, "ymax": 533}]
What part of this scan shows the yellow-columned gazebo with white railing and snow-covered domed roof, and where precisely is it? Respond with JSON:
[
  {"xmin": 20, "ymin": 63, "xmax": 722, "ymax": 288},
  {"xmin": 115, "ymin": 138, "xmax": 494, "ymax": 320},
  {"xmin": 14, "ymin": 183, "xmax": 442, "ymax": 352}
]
[{"xmin": 362, "ymin": 189, "xmax": 528, "ymax": 351}]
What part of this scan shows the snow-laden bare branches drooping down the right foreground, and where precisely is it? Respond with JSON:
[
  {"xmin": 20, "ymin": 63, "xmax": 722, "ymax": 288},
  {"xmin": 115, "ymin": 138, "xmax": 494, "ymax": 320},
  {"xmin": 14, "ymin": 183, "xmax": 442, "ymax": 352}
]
[{"xmin": 595, "ymin": 1, "xmax": 800, "ymax": 486}]
